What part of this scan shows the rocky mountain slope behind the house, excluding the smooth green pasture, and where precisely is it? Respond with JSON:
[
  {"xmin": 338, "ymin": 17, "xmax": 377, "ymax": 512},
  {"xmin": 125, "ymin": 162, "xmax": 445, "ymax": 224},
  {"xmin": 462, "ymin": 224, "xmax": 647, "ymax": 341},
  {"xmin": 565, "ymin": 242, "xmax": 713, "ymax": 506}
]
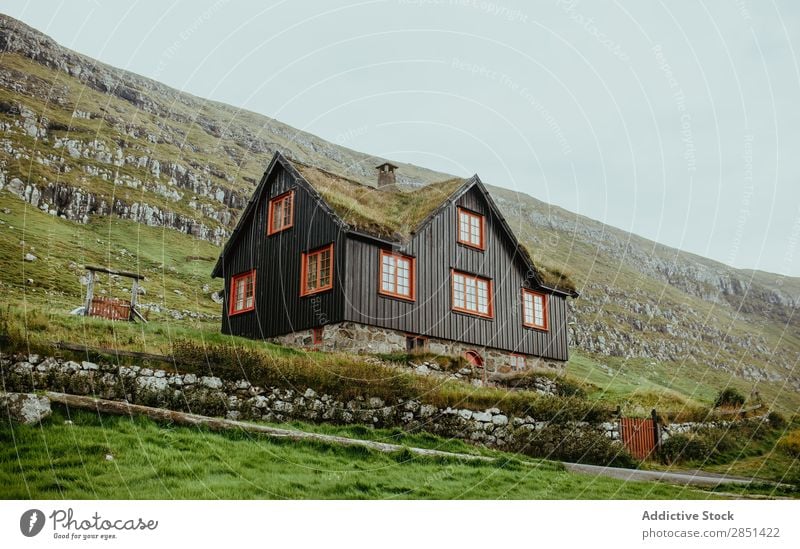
[{"xmin": 0, "ymin": 16, "xmax": 800, "ymax": 398}]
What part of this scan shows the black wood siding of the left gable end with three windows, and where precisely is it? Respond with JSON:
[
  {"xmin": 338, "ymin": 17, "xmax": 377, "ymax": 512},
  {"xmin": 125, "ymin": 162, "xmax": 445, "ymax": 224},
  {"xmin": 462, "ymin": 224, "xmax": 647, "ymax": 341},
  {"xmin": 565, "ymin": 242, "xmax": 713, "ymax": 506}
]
[{"xmin": 217, "ymin": 164, "xmax": 346, "ymax": 339}]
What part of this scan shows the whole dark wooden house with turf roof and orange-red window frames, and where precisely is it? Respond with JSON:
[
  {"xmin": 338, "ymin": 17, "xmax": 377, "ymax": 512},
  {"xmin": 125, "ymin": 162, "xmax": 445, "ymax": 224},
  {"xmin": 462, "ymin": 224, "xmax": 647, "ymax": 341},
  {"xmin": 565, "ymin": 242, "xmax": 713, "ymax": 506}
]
[{"xmin": 213, "ymin": 153, "xmax": 577, "ymax": 369}]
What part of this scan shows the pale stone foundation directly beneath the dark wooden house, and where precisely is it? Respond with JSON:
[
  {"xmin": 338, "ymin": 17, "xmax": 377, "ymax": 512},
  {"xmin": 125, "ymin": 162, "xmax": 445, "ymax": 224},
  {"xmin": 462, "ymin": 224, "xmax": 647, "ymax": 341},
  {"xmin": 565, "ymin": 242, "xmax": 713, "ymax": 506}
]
[{"xmin": 269, "ymin": 322, "xmax": 564, "ymax": 372}]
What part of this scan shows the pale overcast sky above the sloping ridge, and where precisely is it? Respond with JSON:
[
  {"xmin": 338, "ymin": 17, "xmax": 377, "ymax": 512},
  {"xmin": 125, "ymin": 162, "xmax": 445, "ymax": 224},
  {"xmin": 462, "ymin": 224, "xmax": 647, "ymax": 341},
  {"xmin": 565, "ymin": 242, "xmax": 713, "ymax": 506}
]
[{"xmin": 2, "ymin": 0, "xmax": 800, "ymax": 276}]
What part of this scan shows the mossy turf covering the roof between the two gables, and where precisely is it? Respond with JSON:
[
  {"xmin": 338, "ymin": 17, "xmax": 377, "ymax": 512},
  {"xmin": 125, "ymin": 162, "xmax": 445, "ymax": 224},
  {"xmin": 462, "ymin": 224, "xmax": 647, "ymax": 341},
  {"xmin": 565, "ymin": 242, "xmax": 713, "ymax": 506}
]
[{"xmin": 292, "ymin": 161, "xmax": 465, "ymax": 240}]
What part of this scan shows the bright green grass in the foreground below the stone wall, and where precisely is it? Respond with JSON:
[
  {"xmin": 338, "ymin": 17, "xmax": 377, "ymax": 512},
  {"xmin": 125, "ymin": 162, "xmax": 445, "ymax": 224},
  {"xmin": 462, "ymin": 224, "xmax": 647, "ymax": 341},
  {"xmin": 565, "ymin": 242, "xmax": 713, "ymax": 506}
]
[{"xmin": 0, "ymin": 408, "xmax": 716, "ymax": 499}]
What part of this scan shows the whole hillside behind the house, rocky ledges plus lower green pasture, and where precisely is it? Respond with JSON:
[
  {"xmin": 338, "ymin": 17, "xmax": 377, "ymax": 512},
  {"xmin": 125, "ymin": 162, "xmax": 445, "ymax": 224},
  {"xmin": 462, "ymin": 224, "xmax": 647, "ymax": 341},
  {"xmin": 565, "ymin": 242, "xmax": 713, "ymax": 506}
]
[{"xmin": 0, "ymin": 16, "xmax": 800, "ymax": 420}]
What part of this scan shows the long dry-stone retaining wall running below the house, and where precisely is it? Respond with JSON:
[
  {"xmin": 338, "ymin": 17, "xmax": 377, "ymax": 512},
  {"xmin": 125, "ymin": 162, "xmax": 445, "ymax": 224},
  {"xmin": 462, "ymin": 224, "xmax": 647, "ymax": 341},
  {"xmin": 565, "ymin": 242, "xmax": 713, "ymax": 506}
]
[{"xmin": 0, "ymin": 355, "xmax": 599, "ymax": 450}]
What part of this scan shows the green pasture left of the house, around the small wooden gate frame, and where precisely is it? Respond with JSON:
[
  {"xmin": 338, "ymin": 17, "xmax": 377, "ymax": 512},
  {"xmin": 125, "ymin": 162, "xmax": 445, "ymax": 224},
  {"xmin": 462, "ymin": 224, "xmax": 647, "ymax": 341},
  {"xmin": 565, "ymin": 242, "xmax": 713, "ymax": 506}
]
[{"xmin": 0, "ymin": 191, "xmax": 222, "ymax": 319}]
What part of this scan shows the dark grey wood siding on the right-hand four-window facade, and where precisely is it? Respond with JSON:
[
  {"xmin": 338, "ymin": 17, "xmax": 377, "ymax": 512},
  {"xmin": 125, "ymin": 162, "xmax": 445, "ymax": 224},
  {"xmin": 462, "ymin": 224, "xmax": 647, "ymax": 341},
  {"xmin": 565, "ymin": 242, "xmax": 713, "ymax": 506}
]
[{"xmin": 344, "ymin": 187, "xmax": 568, "ymax": 360}]
